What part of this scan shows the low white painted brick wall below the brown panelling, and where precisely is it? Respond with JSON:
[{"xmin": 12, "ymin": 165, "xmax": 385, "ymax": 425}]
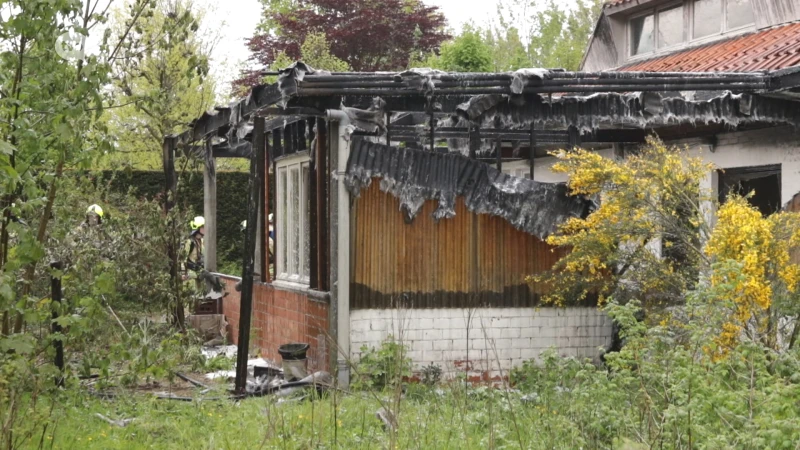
[{"xmin": 350, "ymin": 308, "xmax": 612, "ymax": 377}]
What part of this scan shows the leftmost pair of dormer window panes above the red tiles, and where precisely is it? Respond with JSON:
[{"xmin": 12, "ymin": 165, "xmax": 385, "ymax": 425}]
[{"xmin": 628, "ymin": 4, "xmax": 684, "ymax": 56}]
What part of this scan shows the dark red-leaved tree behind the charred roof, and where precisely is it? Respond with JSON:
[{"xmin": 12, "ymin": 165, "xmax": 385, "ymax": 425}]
[{"xmin": 235, "ymin": 0, "xmax": 450, "ymax": 88}]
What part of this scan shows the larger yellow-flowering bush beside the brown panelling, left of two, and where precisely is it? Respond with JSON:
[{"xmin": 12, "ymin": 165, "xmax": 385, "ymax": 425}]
[{"xmin": 528, "ymin": 138, "xmax": 710, "ymax": 305}]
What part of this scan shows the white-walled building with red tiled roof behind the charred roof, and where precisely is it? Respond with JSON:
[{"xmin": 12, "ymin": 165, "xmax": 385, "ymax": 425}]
[{"xmin": 581, "ymin": 0, "xmax": 800, "ymax": 221}]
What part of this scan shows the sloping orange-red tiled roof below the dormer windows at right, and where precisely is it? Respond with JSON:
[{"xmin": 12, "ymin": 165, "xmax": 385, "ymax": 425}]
[{"xmin": 613, "ymin": 21, "xmax": 800, "ymax": 72}]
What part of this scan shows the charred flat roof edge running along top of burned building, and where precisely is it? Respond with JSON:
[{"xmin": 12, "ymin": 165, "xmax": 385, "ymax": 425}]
[{"xmin": 172, "ymin": 62, "xmax": 800, "ymax": 232}]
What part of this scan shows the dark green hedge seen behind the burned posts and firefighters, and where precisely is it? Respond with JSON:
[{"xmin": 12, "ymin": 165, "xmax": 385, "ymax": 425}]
[{"xmin": 102, "ymin": 170, "xmax": 249, "ymax": 275}]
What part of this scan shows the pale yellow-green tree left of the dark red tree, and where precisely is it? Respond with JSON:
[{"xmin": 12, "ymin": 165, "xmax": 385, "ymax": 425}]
[{"xmin": 106, "ymin": 0, "xmax": 220, "ymax": 169}]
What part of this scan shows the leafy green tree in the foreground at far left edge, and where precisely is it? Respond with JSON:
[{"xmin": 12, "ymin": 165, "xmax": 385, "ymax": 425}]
[{"xmin": 0, "ymin": 0, "xmax": 153, "ymax": 442}]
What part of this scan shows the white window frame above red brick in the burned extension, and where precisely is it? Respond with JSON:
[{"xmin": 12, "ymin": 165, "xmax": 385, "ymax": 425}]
[{"xmin": 275, "ymin": 151, "xmax": 311, "ymax": 287}]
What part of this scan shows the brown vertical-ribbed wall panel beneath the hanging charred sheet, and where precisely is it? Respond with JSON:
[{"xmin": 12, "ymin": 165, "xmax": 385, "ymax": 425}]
[{"xmin": 351, "ymin": 180, "xmax": 563, "ymax": 308}]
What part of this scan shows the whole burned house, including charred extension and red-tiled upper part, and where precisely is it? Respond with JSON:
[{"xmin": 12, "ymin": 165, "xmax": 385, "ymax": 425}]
[{"xmin": 170, "ymin": 0, "xmax": 800, "ymax": 381}]
